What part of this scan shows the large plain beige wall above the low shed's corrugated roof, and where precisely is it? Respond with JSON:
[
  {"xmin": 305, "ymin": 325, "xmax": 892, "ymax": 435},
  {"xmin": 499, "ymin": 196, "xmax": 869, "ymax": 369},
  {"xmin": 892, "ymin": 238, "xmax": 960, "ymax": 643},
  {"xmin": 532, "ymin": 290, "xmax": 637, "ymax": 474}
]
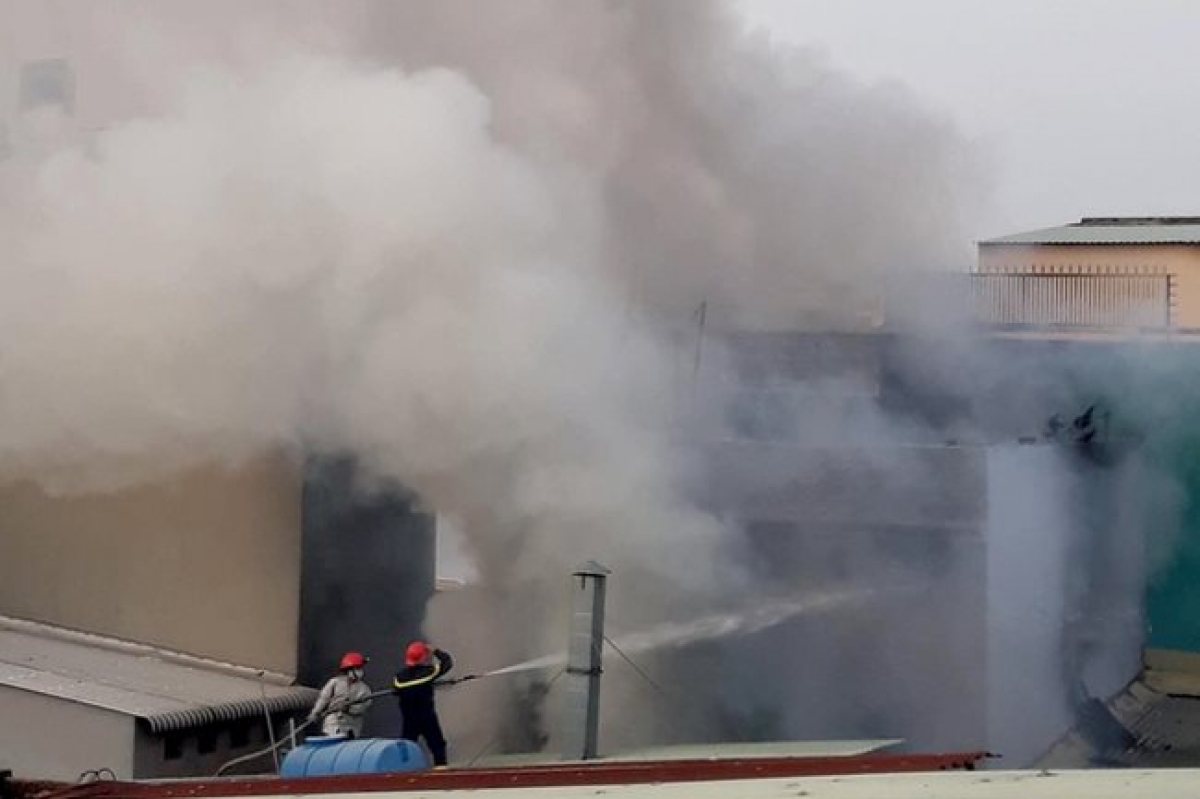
[{"xmin": 0, "ymin": 457, "xmax": 300, "ymax": 674}]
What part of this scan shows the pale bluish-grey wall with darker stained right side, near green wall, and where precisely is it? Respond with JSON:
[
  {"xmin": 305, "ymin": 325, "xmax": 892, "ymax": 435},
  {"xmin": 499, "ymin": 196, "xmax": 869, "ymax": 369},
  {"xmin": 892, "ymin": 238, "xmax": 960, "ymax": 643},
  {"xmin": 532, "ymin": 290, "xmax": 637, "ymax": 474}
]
[{"xmin": 985, "ymin": 445, "xmax": 1145, "ymax": 768}]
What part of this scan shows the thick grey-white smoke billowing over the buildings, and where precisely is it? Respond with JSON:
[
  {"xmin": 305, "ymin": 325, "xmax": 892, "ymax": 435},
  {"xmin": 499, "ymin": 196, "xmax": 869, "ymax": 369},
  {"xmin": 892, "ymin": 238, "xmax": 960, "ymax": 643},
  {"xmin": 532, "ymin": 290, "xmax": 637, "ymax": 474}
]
[{"xmin": 7, "ymin": 0, "xmax": 1142, "ymax": 767}]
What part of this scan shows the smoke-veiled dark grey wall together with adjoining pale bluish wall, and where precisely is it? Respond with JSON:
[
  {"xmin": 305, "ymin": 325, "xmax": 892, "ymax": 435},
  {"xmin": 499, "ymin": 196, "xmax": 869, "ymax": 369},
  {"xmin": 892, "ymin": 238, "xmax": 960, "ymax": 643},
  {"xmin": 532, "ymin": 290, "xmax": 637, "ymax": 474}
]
[{"xmin": 677, "ymin": 444, "xmax": 1146, "ymax": 767}]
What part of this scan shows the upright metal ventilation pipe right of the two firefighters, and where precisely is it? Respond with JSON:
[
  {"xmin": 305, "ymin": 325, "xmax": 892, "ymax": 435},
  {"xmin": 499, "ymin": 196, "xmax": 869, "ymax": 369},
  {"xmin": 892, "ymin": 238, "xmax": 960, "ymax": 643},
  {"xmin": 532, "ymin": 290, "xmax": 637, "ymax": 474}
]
[{"xmin": 562, "ymin": 560, "xmax": 612, "ymax": 761}]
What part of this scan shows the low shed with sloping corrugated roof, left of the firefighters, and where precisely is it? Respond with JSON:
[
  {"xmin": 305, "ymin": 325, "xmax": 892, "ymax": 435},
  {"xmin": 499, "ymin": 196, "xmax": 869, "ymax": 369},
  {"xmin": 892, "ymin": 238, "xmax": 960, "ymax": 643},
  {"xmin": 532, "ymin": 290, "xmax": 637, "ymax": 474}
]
[{"xmin": 0, "ymin": 609, "xmax": 316, "ymax": 781}]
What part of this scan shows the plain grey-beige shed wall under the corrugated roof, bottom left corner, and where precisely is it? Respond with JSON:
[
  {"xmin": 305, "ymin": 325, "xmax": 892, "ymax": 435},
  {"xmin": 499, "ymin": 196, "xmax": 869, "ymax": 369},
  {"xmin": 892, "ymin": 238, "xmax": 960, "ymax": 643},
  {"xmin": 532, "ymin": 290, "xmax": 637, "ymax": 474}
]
[{"xmin": 0, "ymin": 687, "xmax": 133, "ymax": 782}]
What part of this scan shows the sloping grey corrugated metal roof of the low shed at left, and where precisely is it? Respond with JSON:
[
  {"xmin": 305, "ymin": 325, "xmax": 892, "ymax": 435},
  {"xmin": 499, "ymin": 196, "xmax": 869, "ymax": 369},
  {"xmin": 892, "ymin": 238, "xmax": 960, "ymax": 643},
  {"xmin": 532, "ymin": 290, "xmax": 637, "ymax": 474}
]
[{"xmin": 0, "ymin": 619, "xmax": 317, "ymax": 733}]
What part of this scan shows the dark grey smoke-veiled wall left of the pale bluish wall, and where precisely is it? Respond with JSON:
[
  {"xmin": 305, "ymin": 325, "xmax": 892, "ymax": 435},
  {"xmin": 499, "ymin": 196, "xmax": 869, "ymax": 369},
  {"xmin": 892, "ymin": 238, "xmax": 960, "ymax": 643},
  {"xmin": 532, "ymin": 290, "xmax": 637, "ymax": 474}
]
[{"xmin": 662, "ymin": 441, "xmax": 986, "ymax": 750}]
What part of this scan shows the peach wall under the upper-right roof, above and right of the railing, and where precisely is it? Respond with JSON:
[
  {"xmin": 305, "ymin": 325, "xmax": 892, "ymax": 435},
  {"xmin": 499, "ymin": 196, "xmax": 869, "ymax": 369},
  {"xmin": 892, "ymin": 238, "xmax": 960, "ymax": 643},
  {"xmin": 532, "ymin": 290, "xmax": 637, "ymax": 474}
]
[{"xmin": 979, "ymin": 245, "xmax": 1200, "ymax": 328}]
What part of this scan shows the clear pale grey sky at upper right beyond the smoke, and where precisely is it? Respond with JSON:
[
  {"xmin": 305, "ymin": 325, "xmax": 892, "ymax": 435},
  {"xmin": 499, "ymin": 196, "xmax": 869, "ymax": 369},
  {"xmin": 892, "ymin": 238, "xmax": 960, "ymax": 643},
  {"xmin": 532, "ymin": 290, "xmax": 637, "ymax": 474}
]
[{"xmin": 737, "ymin": 0, "xmax": 1200, "ymax": 239}]
